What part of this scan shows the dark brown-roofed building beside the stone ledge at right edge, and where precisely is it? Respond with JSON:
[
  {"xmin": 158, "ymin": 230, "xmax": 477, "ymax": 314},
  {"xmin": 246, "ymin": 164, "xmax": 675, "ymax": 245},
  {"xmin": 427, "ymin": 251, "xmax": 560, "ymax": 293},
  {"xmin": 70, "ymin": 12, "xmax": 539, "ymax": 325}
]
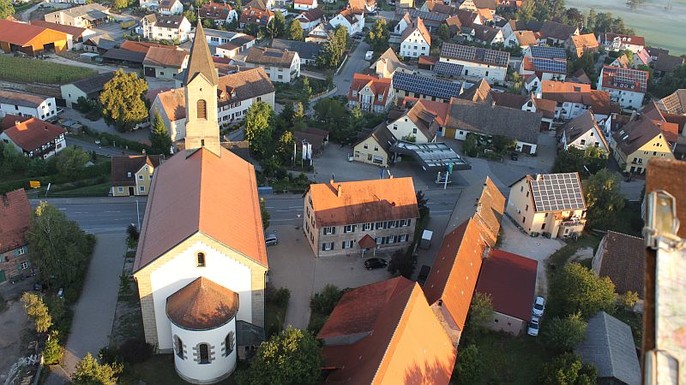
[{"xmin": 592, "ymin": 230, "xmax": 646, "ymax": 299}]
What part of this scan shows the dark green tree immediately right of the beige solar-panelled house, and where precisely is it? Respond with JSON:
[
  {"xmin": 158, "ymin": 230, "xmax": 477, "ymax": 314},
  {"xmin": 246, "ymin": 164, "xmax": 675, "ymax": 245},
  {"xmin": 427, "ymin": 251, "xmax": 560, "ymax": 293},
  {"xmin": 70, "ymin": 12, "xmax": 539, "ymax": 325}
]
[{"xmin": 584, "ymin": 168, "xmax": 625, "ymax": 230}]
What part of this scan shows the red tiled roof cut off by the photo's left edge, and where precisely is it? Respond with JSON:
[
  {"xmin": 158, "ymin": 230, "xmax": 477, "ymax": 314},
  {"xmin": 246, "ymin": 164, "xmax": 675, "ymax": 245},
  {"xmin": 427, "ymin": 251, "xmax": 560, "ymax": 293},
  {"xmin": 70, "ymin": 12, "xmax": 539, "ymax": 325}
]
[{"xmin": 0, "ymin": 189, "xmax": 31, "ymax": 254}]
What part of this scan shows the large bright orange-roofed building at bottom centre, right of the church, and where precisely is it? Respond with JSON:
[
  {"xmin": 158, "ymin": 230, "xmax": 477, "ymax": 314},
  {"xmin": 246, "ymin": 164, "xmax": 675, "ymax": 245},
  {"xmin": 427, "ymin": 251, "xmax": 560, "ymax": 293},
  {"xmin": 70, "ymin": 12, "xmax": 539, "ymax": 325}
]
[{"xmin": 317, "ymin": 277, "xmax": 456, "ymax": 385}]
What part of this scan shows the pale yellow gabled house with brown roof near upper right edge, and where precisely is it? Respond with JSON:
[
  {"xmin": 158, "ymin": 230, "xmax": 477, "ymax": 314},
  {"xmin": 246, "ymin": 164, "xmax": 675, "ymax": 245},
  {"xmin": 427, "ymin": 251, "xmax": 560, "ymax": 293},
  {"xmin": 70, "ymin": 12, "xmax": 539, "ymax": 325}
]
[{"xmin": 612, "ymin": 117, "xmax": 674, "ymax": 174}]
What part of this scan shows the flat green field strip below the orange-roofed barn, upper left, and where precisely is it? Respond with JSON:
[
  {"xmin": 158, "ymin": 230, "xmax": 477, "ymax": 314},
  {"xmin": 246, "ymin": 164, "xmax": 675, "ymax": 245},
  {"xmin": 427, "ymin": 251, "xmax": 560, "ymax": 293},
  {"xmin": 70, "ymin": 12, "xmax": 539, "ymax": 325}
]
[{"xmin": 0, "ymin": 55, "xmax": 96, "ymax": 84}]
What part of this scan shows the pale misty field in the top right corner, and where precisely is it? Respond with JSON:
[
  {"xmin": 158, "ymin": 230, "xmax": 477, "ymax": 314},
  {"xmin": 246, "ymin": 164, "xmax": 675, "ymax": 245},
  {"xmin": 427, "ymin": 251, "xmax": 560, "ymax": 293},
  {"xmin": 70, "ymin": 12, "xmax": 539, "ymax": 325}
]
[{"xmin": 565, "ymin": 0, "xmax": 686, "ymax": 55}]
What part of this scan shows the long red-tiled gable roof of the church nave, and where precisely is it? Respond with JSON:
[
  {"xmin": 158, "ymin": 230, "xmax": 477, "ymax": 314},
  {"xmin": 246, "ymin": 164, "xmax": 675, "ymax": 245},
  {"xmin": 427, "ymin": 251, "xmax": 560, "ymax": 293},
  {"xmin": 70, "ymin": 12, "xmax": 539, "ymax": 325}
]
[{"xmin": 134, "ymin": 148, "xmax": 268, "ymax": 271}]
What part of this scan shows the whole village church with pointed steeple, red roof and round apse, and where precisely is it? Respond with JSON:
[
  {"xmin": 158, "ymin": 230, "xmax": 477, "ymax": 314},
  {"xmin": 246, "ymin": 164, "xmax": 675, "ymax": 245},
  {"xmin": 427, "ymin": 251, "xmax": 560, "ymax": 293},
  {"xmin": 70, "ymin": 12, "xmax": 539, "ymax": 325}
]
[{"xmin": 133, "ymin": 22, "xmax": 268, "ymax": 384}]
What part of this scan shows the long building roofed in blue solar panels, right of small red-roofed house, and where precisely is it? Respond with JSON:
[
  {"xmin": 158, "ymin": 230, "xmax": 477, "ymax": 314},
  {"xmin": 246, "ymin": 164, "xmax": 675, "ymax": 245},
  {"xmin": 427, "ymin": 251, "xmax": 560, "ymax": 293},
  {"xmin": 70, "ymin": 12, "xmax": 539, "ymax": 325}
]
[{"xmin": 392, "ymin": 72, "xmax": 463, "ymax": 103}]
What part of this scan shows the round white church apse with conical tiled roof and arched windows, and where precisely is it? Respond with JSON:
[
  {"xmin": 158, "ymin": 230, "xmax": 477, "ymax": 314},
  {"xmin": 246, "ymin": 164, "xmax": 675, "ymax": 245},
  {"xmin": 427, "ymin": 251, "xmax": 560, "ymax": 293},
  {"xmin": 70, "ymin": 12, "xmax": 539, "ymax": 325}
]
[{"xmin": 166, "ymin": 277, "xmax": 238, "ymax": 384}]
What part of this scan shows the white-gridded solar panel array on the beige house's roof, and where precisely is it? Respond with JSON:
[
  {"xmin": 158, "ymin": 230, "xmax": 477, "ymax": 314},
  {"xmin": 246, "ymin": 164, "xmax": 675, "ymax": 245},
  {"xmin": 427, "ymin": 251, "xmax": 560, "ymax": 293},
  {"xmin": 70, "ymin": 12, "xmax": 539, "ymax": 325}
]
[{"xmin": 531, "ymin": 173, "xmax": 586, "ymax": 212}]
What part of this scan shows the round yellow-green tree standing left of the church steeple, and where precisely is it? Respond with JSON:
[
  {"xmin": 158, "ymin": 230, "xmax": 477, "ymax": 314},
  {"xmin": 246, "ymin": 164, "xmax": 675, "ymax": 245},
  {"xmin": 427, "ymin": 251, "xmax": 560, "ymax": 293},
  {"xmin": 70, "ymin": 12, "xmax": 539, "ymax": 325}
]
[{"xmin": 100, "ymin": 69, "xmax": 148, "ymax": 131}]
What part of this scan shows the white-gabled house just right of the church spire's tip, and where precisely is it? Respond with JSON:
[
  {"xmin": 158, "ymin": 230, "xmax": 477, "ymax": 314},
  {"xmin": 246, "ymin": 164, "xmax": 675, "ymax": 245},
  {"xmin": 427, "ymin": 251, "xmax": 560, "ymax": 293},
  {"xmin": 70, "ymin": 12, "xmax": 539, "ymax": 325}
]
[{"xmin": 245, "ymin": 47, "xmax": 300, "ymax": 83}]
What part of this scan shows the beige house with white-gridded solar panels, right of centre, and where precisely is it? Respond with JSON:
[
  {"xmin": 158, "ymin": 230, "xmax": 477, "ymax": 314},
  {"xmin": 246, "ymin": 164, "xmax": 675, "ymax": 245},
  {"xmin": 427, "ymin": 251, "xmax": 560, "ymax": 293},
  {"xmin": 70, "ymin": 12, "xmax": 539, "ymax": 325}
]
[{"xmin": 506, "ymin": 172, "xmax": 586, "ymax": 238}]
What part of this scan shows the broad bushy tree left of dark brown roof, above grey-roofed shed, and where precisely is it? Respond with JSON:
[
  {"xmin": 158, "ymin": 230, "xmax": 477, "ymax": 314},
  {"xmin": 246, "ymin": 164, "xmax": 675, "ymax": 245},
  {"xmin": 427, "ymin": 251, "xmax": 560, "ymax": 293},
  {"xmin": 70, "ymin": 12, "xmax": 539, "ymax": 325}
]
[{"xmin": 548, "ymin": 262, "xmax": 615, "ymax": 319}]
